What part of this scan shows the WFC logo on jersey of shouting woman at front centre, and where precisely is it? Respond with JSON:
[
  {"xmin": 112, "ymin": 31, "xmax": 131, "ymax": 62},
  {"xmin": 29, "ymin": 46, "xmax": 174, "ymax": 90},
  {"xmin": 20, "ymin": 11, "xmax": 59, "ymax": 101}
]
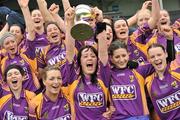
[{"xmin": 77, "ymin": 92, "xmax": 104, "ymax": 108}]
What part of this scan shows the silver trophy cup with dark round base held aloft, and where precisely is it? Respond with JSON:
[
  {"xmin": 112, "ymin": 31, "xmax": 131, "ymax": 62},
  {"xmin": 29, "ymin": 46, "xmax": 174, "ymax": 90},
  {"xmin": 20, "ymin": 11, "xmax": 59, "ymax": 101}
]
[{"xmin": 71, "ymin": 4, "xmax": 94, "ymax": 41}]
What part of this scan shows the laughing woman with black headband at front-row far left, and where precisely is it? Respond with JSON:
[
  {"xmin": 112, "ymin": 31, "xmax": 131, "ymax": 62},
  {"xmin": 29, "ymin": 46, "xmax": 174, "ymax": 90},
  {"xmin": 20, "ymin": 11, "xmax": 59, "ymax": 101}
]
[{"xmin": 0, "ymin": 65, "xmax": 35, "ymax": 120}]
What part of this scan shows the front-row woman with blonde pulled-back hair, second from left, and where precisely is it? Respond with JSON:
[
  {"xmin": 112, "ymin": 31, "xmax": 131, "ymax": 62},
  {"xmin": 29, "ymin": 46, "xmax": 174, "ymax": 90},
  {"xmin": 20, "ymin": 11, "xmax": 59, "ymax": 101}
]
[{"xmin": 30, "ymin": 66, "xmax": 71, "ymax": 120}]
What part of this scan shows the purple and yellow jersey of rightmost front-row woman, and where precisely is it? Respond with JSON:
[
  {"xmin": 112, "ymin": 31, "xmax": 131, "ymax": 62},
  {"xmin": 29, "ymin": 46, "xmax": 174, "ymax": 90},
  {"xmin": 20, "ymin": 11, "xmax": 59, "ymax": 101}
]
[{"xmin": 146, "ymin": 66, "xmax": 180, "ymax": 120}]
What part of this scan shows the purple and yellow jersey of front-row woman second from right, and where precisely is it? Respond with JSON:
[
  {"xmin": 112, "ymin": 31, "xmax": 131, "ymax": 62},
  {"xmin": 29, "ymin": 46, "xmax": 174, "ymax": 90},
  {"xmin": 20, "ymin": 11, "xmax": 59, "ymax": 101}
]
[{"xmin": 101, "ymin": 61, "xmax": 154, "ymax": 120}]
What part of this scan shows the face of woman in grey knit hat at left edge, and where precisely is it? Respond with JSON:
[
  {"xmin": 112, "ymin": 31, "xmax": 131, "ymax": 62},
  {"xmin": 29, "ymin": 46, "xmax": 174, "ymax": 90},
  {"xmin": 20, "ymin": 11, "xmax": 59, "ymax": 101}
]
[{"xmin": 3, "ymin": 36, "xmax": 17, "ymax": 55}]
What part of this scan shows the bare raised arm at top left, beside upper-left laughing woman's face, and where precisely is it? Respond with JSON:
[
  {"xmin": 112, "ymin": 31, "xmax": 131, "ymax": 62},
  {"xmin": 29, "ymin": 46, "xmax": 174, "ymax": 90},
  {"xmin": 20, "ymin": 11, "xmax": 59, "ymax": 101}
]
[{"xmin": 18, "ymin": 0, "xmax": 35, "ymax": 40}]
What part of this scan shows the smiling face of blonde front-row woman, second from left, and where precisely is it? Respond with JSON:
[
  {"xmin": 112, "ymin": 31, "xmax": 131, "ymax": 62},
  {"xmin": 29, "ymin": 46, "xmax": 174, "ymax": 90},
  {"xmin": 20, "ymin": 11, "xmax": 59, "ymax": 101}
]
[{"xmin": 43, "ymin": 70, "xmax": 62, "ymax": 97}]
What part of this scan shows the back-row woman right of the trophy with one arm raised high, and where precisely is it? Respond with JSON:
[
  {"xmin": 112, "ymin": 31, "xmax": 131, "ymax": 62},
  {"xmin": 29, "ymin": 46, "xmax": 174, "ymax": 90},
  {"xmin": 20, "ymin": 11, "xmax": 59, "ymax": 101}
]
[{"xmin": 114, "ymin": 0, "xmax": 160, "ymax": 64}]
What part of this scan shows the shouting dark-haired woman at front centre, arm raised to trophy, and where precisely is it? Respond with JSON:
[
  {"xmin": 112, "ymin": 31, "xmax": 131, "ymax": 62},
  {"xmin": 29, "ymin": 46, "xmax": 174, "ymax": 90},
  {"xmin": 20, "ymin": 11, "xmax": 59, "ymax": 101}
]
[{"xmin": 62, "ymin": 8, "xmax": 112, "ymax": 120}]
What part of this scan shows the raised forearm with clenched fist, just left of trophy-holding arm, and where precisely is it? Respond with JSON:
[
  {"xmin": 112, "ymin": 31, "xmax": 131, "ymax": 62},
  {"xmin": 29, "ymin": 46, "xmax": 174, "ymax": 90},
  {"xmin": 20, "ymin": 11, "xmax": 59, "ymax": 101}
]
[{"xmin": 49, "ymin": 3, "xmax": 65, "ymax": 33}]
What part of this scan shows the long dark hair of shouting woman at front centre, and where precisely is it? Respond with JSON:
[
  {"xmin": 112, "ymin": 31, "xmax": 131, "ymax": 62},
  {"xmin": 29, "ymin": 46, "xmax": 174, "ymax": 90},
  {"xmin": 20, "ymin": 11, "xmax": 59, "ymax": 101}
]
[{"xmin": 77, "ymin": 45, "xmax": 98, "ymax": 84}]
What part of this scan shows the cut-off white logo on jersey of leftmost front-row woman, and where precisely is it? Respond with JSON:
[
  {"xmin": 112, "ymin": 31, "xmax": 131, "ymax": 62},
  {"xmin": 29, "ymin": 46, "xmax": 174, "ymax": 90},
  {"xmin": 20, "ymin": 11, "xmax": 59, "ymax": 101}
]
[{"xmin": 3, "ymin": 111, "xmax": 28, "ymax": 120}]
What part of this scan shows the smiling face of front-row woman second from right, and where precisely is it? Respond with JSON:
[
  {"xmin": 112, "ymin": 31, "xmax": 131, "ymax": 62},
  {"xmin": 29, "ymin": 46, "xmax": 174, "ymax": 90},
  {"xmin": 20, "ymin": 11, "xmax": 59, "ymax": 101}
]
[{"xmin": 111, "ymin": 48, "xmax": 129, "ymax": 69}]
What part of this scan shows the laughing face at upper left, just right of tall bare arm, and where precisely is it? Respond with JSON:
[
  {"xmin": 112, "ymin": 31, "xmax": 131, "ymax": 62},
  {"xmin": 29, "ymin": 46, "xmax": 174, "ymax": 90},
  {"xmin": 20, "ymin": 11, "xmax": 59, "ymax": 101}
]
[{"xmin": 31, "ymin": 10, "xmax": 44, "ymax": 28}]
